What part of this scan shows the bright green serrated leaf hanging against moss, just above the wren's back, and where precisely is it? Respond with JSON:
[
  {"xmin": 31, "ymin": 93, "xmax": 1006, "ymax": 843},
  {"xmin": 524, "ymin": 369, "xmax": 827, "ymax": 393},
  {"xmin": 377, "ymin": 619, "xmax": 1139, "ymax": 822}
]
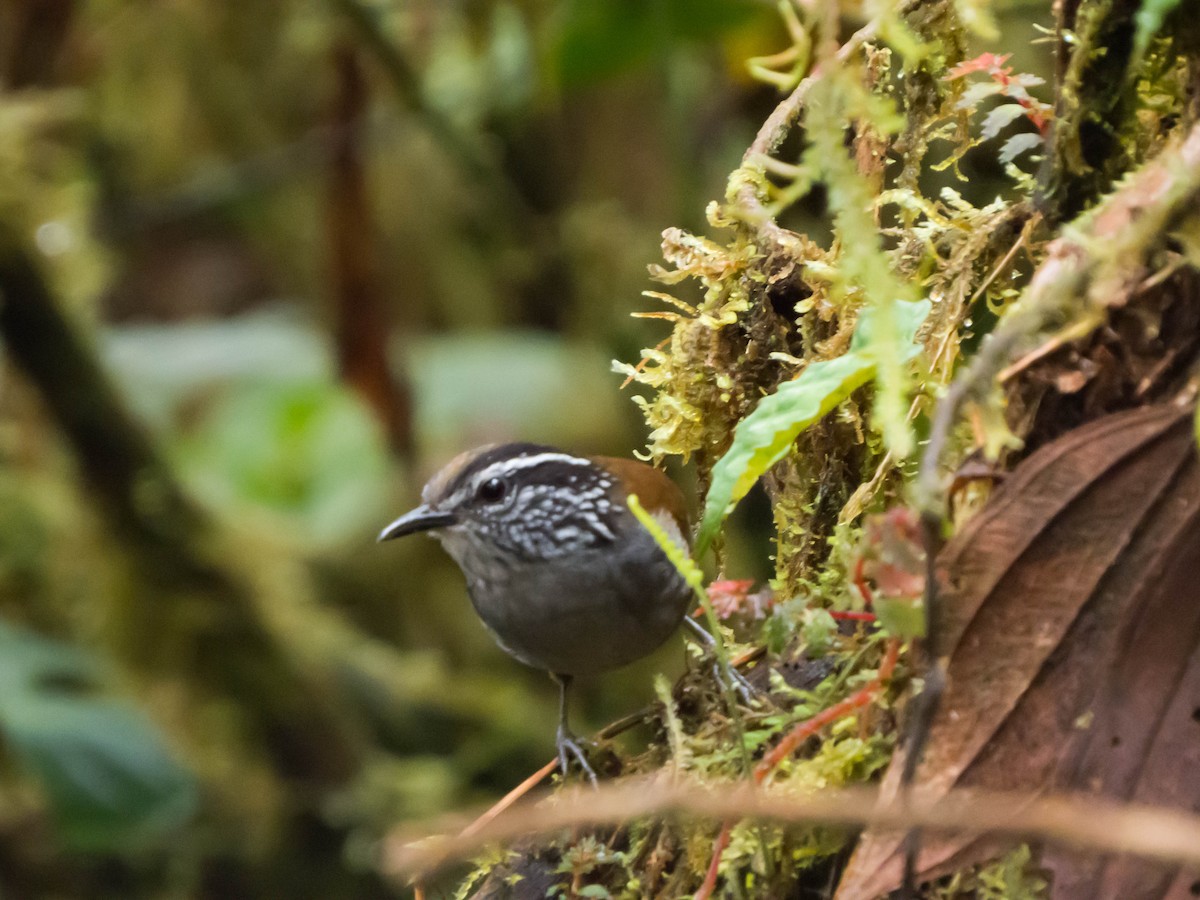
[{"xmin": 696, "ymin": 300, "xmax": 930, "ymax": 557}]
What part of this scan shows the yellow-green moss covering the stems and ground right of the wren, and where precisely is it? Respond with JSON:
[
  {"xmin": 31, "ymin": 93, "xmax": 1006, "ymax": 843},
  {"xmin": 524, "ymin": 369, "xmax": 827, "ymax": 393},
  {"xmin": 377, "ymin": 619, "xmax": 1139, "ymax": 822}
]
[{"xmin": 460, "ymin": 0, "xmax": 1189, "ymax": 899}]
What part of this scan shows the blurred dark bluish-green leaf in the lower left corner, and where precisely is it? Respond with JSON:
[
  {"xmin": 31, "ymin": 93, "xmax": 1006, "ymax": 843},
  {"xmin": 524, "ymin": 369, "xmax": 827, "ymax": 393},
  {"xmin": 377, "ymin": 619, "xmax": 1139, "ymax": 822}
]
[{"xmin": 0, "ymin": 623, "xmax": 197, "ymax": 851}]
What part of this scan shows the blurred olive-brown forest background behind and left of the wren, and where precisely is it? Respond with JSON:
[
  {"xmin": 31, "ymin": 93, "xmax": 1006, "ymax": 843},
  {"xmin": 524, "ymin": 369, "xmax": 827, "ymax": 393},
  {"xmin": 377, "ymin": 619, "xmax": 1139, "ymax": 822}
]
[{"xmin": 0, "ymin": 0, "xmax": 1045, "ymax": 899}]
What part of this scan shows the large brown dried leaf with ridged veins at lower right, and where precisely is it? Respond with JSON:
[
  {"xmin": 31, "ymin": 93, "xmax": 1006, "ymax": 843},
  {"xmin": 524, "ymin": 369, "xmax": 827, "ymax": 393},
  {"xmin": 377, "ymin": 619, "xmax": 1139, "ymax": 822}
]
[{"xmin": 838, "ymin": 406, "xmax": 1200, "ymax": 900}]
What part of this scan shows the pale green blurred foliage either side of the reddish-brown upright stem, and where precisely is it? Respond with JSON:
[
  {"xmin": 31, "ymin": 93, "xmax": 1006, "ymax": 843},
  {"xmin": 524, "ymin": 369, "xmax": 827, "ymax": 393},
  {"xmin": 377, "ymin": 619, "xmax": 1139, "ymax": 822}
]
[{"xmin": 104, "ymin": 311, "xmax": 629, "ymax": 544}]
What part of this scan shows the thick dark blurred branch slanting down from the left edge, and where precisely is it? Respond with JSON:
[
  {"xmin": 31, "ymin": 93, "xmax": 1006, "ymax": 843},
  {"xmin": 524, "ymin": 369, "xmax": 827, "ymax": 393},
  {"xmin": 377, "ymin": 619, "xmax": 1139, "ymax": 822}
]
[{"xmin": 0, "ymin": 228, "xmax": 358, "ymax": 781}]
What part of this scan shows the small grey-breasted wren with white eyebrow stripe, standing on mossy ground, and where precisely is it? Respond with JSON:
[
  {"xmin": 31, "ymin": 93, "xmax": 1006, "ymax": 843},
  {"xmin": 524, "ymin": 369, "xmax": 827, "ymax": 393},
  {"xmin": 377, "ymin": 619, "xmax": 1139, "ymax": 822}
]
[{"xmin": 379, "ymin": 444, "xmax": 691, "ymax": 781}]
